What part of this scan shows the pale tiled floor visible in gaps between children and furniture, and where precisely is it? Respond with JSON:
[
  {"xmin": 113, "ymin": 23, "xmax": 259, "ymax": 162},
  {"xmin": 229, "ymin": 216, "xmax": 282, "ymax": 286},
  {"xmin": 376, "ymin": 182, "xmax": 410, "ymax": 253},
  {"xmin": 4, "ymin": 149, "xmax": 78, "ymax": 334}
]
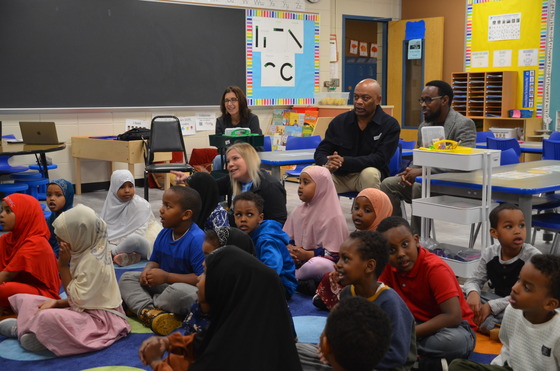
[{"xmin": 74, "ymin": 182, "xmax": 550, "ymax": 252}]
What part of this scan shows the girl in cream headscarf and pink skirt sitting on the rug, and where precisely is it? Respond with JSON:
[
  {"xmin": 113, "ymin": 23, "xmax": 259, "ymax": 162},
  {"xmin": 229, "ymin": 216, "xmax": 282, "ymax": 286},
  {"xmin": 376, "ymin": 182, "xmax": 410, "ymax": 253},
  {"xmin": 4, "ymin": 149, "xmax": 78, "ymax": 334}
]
[{"xmin": 0, "ymin": 205, "xmax": 130, "ymax": 356}]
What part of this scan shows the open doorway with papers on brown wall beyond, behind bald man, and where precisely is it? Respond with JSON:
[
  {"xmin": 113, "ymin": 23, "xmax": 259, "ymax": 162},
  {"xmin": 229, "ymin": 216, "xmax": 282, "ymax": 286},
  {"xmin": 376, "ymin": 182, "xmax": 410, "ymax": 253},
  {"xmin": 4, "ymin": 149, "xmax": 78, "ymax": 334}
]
[{"xmin": 341, "ymin": 15, "xmax": 389, "ymax": 105}]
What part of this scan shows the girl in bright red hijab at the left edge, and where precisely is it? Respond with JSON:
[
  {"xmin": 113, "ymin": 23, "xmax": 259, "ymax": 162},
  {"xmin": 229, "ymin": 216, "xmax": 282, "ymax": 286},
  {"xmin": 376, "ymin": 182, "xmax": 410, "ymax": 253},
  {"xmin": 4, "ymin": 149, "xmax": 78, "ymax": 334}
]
[{"xmin": 0, "ymin": 193, "xmax": 60, "ymax": 315}]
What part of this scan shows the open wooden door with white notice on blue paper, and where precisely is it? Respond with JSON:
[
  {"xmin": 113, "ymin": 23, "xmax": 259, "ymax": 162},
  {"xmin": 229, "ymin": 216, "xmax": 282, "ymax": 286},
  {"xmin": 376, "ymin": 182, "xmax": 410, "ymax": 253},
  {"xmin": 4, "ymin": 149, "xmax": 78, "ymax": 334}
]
[{"xmin": 387, "ymin": 17, "xmax": 443, "ymax": 135}]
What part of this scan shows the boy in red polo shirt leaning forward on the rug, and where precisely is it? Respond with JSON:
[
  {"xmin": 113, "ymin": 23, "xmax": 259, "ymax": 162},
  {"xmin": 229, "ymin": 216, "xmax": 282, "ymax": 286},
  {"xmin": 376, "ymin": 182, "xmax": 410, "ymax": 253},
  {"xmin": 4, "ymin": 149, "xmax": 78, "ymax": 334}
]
[{"xmin": 377, "ymin": 217, "xmax": 476, "ymax": 370}]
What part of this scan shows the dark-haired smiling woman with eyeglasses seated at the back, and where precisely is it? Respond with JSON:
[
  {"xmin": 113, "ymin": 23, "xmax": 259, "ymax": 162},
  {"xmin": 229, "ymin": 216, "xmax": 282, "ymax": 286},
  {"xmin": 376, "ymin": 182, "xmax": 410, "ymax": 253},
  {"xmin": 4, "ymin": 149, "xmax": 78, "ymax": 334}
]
[{"xmin": 216, "ymin": 86, "xmax": 262, "ymax": 135}]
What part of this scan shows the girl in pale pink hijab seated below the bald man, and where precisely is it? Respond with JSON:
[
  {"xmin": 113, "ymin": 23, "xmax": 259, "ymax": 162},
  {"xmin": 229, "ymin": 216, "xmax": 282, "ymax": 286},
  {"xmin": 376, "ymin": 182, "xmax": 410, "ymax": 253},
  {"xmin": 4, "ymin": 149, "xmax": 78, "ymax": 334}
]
[{"xmin": 284, "ymin": 166, "xmax": 348, "ymax": 286}]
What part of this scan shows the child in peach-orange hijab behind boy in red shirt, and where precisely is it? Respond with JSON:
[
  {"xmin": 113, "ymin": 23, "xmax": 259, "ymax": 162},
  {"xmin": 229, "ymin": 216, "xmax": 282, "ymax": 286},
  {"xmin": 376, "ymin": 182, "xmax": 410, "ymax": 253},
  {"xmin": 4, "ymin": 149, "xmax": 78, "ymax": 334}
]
[{"xmin": 313, "ymin": 188, "xmax": 393, "ymax": 310}]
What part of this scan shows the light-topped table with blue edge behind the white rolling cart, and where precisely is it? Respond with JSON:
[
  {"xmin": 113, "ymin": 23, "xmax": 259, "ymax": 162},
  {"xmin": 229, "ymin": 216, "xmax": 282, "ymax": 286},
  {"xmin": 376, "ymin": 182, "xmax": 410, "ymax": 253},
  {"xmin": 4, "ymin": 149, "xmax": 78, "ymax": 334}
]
[{"xmin": 424, "ymin": 160, "xmax": 560, "ymax": 241}]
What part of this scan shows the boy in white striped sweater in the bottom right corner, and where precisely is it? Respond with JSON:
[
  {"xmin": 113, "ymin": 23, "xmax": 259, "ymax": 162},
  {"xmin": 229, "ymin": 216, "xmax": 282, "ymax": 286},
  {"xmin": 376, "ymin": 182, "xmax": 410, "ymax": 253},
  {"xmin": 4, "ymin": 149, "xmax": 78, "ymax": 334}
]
[{"xmin": 449, "ymin": 255, "xmax": 560, "ymax": 371}]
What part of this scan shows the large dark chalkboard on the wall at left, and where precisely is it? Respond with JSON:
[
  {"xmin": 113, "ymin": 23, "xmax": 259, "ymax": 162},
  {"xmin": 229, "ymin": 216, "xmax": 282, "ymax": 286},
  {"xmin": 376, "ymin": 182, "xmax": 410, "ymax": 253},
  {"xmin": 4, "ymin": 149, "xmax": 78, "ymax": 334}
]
[{"xmin": 0, "ymin": 0, "xmax": 246, "ymax": 109}]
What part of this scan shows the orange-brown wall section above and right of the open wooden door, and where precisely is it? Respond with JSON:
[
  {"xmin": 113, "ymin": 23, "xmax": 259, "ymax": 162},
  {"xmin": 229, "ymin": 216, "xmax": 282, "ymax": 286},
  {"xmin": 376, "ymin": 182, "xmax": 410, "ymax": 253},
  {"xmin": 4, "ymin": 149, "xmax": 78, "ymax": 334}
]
[{"xmin": 402, "ymin": 0, "xmax": 466, "ymax": 82}]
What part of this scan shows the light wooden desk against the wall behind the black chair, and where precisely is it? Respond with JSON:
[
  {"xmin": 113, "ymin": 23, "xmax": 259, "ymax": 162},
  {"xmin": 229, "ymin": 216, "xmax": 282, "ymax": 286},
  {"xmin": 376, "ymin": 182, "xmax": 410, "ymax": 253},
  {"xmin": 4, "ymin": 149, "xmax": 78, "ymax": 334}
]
[{"xmin": 72, "ymin": 137, "xmax": 171, "ymax": 195}]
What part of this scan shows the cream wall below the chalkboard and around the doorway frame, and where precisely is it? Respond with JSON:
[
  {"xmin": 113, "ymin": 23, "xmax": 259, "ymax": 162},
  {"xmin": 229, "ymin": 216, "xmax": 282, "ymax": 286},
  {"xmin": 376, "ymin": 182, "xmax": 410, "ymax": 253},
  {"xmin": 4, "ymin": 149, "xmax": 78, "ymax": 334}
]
[{"xmin": 0, "ymin": 0, "xmax": 401, "ymax": 189}]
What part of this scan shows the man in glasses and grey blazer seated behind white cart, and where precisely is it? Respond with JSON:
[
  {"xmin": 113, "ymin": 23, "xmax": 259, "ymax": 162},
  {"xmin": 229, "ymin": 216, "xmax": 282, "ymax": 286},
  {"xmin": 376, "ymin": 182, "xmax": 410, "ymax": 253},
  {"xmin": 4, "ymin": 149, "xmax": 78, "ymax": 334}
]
[{"xmin": 381, "ymin": 80, "xmax": 476, "ymax": 233}]
